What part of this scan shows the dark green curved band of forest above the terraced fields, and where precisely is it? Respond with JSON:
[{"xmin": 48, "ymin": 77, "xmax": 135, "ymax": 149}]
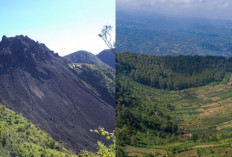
[{"xmin": 117, "ymin": 53, "xmax": 232, "ymax": 90}]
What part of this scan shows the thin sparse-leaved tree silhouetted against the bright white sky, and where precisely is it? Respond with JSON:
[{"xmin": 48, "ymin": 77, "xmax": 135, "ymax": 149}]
[{"xmin": 98, "ymin": 25, "xmax": 116, "ymax": 54}]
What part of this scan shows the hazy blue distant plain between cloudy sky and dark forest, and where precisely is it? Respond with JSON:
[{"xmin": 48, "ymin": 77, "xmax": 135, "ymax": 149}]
[{"xmin": 116, "ymin": 12, "xmax": 232, "ymax": 57}]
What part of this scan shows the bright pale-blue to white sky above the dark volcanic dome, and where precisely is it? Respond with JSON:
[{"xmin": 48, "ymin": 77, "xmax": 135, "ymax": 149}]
[{"xmin": 0, "ymin": 0, "xmax": 115, "ymax": 56}]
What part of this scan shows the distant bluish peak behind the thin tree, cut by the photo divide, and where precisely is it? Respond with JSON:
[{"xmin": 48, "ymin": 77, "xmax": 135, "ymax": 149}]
[{"xmin": 97, "ymin": 49, "xmax": 115, "ymax": 69}]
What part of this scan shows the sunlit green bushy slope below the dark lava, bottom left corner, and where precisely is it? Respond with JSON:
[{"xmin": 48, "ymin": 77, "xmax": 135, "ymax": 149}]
[{"xmin": 0, "ymin": 105, "xmax": 74, "ymax": 157}]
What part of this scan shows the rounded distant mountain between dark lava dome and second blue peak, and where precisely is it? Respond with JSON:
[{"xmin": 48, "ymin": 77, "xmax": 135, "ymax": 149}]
[{"xmin": 64, "ymin": 50, "xmax": 104, "ymax": 65}]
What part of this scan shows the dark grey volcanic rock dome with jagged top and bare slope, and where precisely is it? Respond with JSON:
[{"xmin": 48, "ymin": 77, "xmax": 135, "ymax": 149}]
[{"xmin": 0, "ymin": 36, "xmax": 115, "ymax": 151}]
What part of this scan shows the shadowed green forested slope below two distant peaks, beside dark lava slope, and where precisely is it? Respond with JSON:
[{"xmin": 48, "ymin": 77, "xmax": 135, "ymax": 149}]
[{"xmin": 70, "ymin": 63, "xmax": 115, "ymax": 107}]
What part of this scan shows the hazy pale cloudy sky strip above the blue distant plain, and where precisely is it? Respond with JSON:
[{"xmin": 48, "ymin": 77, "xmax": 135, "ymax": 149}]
[{"xmin": 117, "ymin": 0, "xmax": 232, "ymax": 20}]
